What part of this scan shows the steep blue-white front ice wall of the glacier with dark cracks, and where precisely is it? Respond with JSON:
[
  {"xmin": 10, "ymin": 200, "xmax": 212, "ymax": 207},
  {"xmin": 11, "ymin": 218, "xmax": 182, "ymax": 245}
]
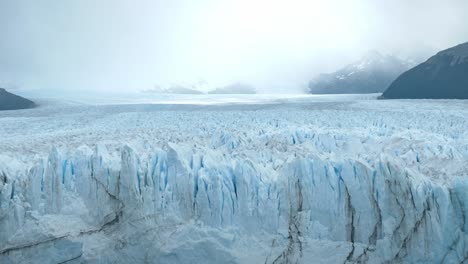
[{"xmin": 0, "ymin": 142, "xmax": 468, "ymax": 263}]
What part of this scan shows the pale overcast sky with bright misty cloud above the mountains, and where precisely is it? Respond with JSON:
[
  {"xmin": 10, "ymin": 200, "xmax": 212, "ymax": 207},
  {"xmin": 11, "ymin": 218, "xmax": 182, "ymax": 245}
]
[{"xmin": 0, "ymin": 0, "xmax": 468, "ymax": 92}]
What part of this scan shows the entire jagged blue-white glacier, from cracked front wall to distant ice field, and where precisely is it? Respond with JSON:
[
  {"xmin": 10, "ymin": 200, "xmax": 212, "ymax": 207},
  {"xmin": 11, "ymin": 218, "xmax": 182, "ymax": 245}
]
[{"xmin": 0, "ymin": 96, "xmax": 468, "ymax": 263}]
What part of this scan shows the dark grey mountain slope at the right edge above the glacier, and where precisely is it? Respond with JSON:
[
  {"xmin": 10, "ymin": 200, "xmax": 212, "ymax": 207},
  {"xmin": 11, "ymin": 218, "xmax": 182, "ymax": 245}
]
[{"xmin": 382, "ymin": 42, "xmax": 468, "ymax": 99}]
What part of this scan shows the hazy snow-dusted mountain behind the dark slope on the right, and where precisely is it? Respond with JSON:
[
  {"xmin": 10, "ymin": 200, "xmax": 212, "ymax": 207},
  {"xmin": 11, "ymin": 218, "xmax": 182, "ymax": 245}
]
[{"xmin": 309, "ymin": 51, "xmax": 412, "ymax": 94}]
